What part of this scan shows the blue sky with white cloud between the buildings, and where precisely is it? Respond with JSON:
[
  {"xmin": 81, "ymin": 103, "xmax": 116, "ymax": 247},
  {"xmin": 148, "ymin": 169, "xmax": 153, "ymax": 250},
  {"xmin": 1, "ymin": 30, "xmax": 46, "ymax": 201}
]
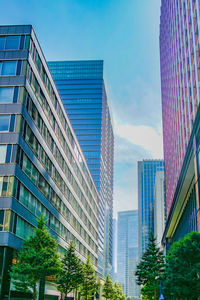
[{"xmin": 0, "ymin": 0, "xmax": 163, "ymax": 216}]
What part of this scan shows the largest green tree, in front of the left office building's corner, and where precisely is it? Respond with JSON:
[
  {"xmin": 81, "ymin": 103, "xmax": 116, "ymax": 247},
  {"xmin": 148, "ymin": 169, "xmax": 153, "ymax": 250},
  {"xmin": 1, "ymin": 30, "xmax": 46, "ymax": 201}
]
[{"xmin": 10, "ymin": 216, "xmax": 61, "ymax": 300}]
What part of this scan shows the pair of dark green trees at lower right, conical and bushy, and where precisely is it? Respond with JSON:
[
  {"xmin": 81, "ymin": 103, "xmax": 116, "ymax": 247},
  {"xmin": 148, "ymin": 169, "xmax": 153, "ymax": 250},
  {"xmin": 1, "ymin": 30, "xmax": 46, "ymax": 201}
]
[{"xmin": 135, "ymin": 232, "xmax": 200, "ymax": 300}]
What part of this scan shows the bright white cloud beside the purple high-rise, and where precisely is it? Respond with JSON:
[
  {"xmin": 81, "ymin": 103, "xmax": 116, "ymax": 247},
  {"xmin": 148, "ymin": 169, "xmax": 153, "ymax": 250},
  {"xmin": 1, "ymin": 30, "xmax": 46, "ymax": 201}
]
[{"xmin": 115, "ymin": 124, "xmax": 163, "ymax": 159}]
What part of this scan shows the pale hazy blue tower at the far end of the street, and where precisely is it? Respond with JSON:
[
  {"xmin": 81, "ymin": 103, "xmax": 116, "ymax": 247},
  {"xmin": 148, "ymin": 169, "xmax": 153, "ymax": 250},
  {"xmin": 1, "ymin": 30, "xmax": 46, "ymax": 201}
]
[{"xmin": 117, "ymin": 210, "xmax": 139, "ymax": 297}]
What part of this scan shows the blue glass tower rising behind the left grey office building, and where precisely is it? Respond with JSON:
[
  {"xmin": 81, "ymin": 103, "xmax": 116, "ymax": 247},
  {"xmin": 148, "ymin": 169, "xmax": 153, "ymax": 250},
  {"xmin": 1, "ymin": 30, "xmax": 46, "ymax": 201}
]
[{"xmin": 48, "ymin": 60, "xmax": 114, "ymax": 275}]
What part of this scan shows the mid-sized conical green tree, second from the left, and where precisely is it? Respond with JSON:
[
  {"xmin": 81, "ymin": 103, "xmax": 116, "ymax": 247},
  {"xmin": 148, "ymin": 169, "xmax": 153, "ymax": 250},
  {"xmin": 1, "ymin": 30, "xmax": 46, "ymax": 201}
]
[{"xmin": 56, "ymin": 242, "xmax": 84, "ymax": 296}]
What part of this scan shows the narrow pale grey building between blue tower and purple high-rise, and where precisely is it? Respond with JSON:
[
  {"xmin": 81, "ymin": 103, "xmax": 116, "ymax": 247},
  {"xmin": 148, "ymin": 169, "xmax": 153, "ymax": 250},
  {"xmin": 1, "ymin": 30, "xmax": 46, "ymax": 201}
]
[{"xmin": 154, "ymin": 171, "xmax": 165, "ymax": 247}]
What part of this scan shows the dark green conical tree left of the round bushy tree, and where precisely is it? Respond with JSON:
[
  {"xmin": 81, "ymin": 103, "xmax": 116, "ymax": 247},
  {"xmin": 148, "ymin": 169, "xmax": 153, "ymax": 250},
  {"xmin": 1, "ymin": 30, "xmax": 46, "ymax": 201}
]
[{"xmin": 135, "ymin": 233, "xmax": 164, "ymax": 300}]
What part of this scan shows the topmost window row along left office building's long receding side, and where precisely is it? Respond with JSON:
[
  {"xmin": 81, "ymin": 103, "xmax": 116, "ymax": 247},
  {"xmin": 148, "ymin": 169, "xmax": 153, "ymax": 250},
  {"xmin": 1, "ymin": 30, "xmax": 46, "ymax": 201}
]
[{"xmin": 28, "ymin": 40, "xmax": 98, "ymax": 201}]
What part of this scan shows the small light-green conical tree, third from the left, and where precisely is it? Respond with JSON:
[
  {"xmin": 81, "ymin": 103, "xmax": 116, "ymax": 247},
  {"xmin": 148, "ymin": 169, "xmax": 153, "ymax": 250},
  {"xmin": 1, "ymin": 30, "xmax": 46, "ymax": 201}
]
[{"xmin": 80, "ymin": 257, "xmax": 99, "ymax": 300}]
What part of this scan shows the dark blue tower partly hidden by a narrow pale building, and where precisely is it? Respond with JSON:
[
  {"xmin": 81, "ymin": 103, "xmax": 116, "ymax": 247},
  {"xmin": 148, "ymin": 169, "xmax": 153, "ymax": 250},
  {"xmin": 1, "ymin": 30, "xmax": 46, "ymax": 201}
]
[{"xmin": 138, "ymin": 160, "xmax": 164, "ymax": 257}]
